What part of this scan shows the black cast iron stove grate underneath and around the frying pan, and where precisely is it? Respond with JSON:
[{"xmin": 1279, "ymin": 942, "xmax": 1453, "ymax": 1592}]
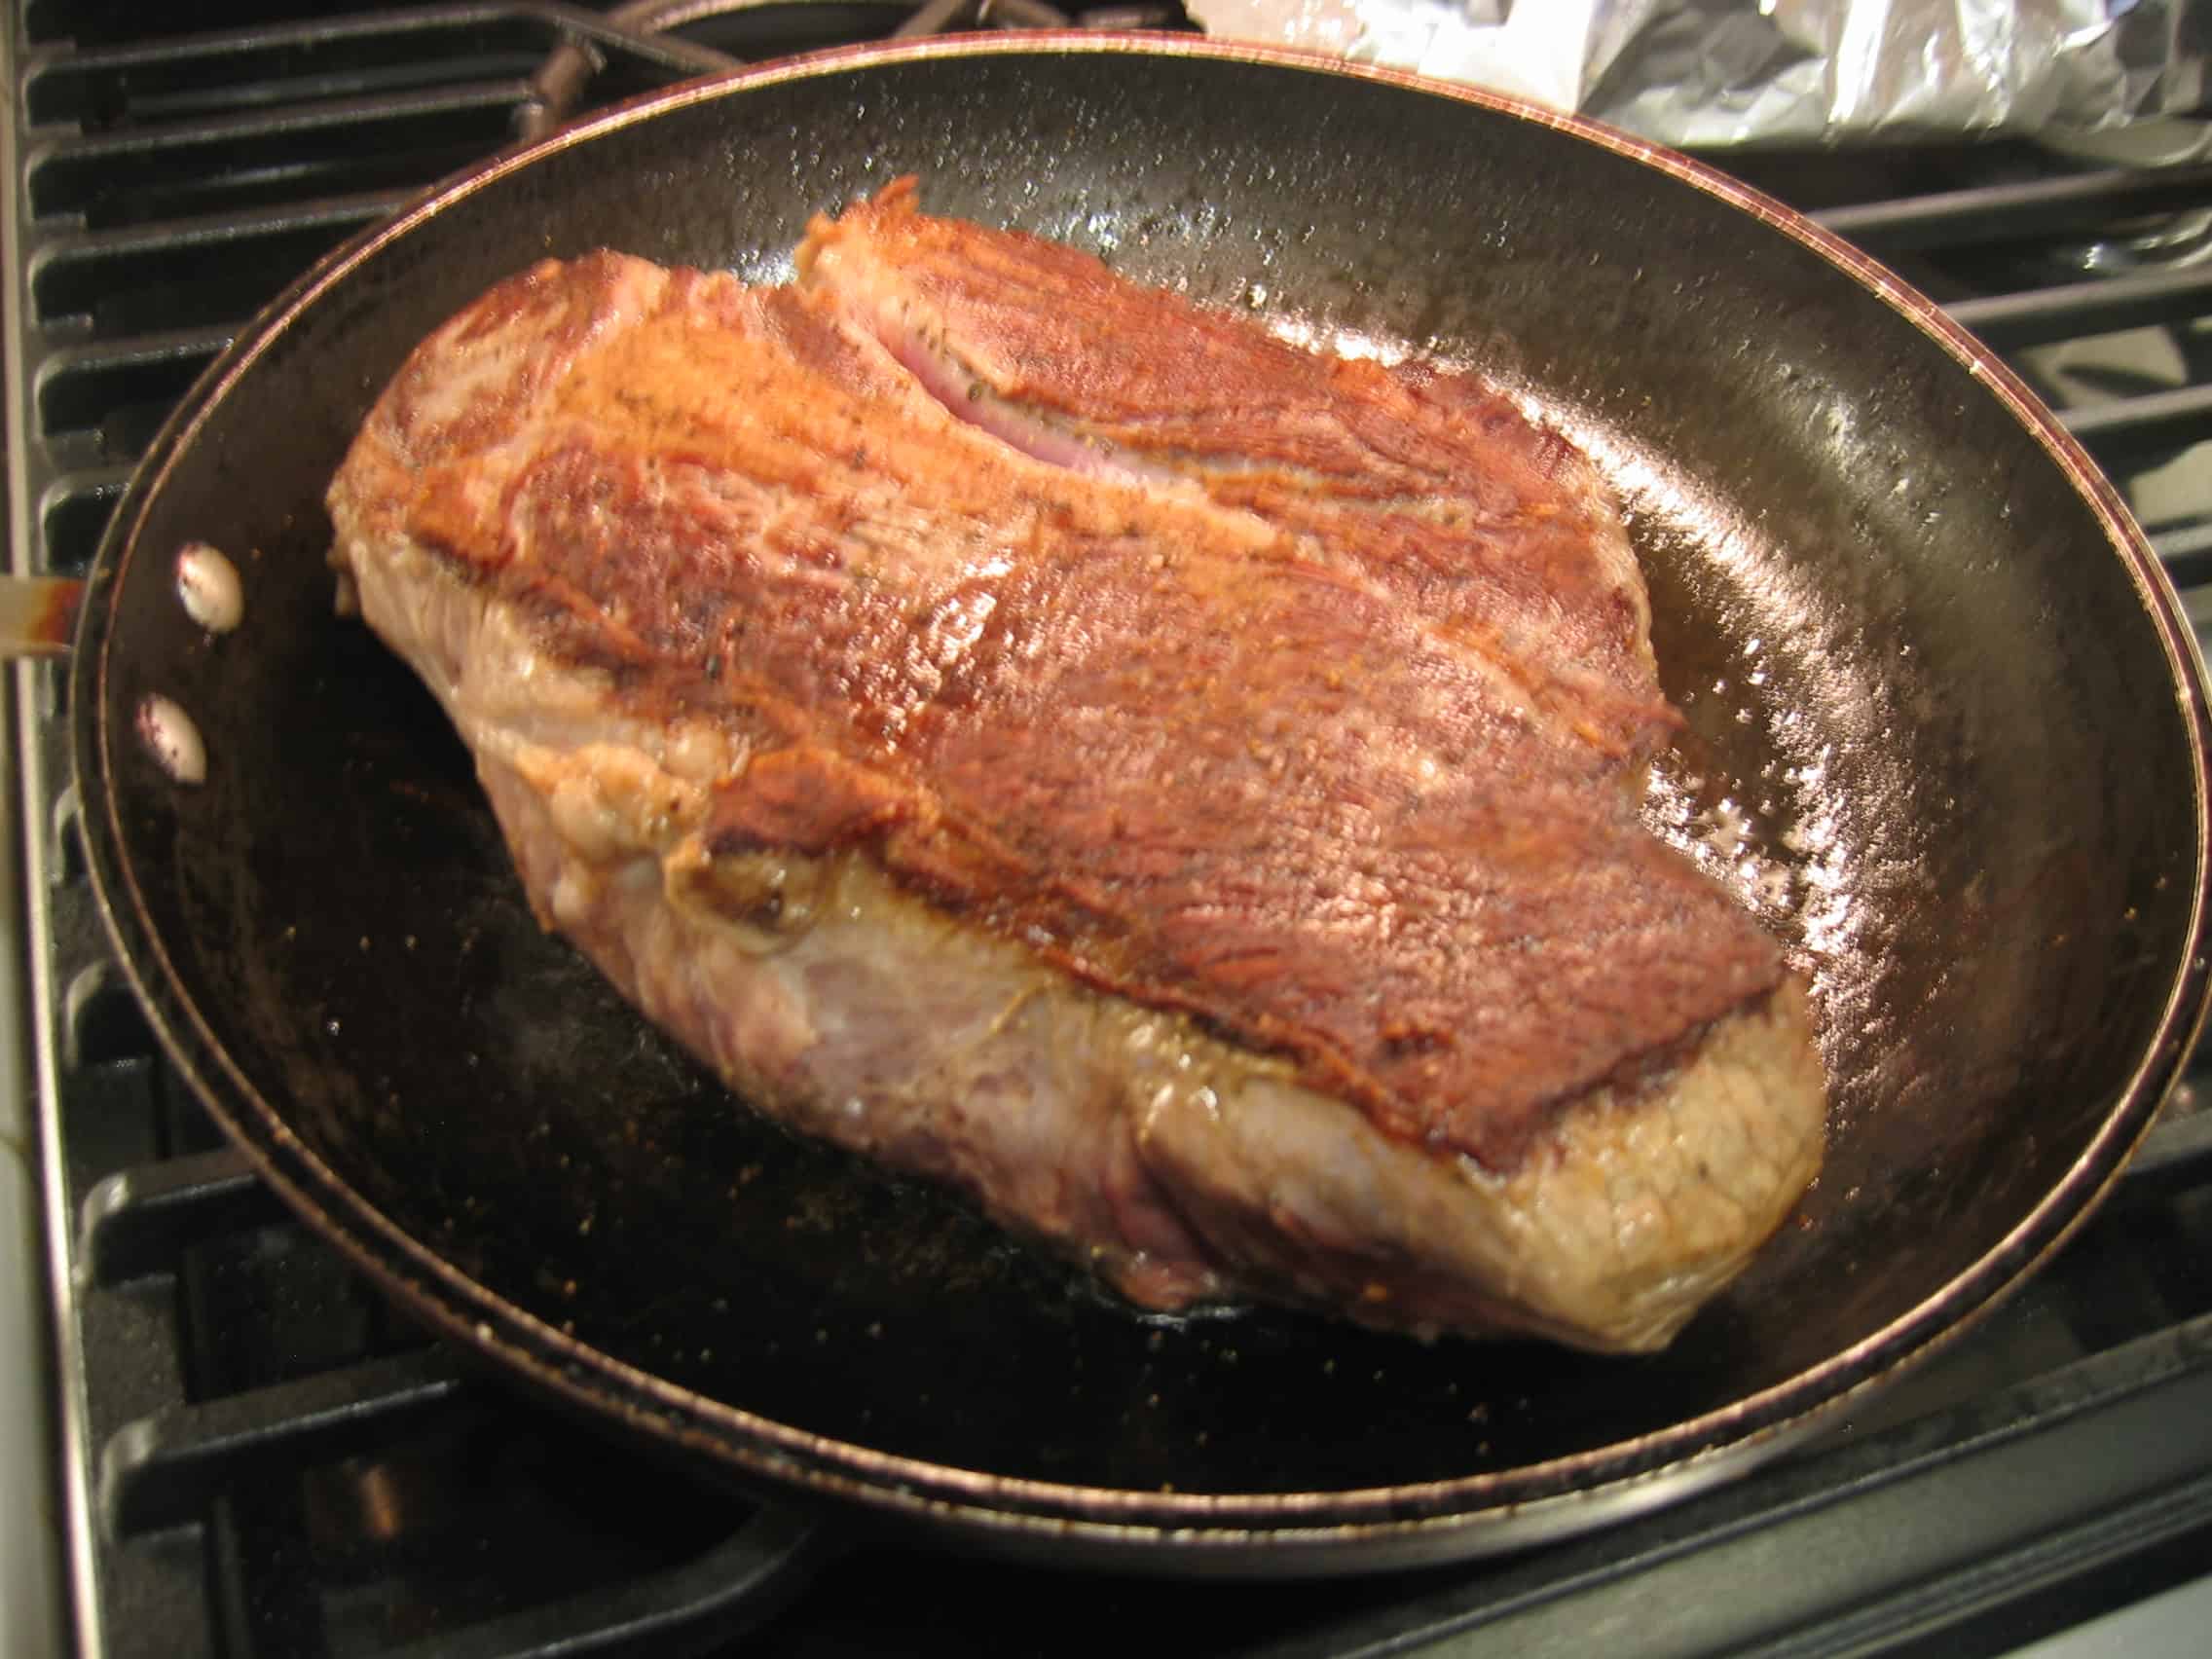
[{"xmin": 7, "ymin": 0, "xmax": 2212, "ymax": 1657}]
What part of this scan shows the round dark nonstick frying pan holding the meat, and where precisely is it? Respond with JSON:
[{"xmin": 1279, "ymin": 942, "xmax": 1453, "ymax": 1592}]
[{"xmin": 71, "ymin": 35, "xmax": 2207, "ymax": 1572}]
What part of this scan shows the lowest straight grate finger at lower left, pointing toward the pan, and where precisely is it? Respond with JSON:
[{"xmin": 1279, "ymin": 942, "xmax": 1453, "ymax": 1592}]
[{"xmin": 99, "ymin": 1347, "xmax": 464, "ymax": 1539}]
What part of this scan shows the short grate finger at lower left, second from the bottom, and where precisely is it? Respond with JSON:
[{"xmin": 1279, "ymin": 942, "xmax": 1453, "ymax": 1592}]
[{"xmin": 75, "ymin": 1146, "xmax": 290, "ymax": 1290}]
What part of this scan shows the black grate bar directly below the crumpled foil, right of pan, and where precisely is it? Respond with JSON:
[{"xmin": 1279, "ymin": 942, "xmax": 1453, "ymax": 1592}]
[{"xmin": 1814, "ymin": 162, "xmax": 2212, "ymax": 252}]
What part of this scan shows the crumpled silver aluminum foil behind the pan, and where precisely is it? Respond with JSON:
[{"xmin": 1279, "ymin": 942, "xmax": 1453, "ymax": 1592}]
[{"xmin": 1186, "ymin": 0, "xmax": 2212, "ymax": 148}]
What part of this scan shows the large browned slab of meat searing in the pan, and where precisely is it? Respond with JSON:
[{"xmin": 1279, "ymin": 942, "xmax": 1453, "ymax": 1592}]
[{"xmin": 332, "ymin": 188, "xmax": 1823, "ymax": 1347}]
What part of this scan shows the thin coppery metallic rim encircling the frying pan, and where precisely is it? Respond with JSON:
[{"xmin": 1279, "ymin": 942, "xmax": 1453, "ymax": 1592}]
[{"xmin": 71, "ymin": 31, "xmax": 2212, "ymax": 1567}]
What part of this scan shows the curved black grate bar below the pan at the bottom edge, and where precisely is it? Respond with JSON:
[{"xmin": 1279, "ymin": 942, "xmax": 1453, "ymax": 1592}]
[{"xmin": 387, "ymin": 1504, "xmax": 845, "ymax": 1659}]
